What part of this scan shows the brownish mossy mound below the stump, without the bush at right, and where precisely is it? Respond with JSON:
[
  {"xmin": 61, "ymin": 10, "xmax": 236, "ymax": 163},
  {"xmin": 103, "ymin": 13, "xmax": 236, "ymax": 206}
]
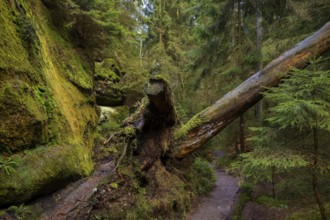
[{"xmin": 91, "ymin": 160, "xmax": 191, "ymax": 219}]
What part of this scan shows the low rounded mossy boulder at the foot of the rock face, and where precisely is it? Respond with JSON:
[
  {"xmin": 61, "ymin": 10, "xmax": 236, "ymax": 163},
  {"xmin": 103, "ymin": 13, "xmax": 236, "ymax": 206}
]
[{"xmin": 0, "ymin": 145, "xmax": 93, "ymax": 205}]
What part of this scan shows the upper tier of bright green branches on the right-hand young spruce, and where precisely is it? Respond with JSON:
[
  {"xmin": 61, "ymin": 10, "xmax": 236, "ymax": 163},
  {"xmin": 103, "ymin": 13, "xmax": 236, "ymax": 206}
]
[{"xmin": 265, "ymin": 58, "xmax": 330, "ymax": 130}]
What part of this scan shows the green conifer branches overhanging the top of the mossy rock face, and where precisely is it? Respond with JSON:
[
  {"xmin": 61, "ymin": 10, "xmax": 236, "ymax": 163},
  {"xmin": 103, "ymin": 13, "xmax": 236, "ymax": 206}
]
[{"xmin": 43, "ymin": 0, "xmax": 140, "ymax": 64}]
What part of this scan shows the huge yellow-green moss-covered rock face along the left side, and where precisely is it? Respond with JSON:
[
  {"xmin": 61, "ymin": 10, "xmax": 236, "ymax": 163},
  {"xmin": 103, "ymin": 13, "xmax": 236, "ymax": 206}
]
[{"xmin": 0, "ymin": 0, "xmax": 97, "ymax": 206}]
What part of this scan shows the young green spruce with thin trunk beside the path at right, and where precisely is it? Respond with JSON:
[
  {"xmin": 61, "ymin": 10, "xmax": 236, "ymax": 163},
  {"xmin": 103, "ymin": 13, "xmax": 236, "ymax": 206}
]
[{"xmin": 232, "ymin": 58, "xmax": 330, "ymax": 220}]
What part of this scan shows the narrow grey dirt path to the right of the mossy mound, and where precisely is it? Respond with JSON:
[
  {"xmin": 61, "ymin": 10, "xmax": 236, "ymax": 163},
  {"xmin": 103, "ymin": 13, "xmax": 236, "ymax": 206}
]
[{"xmin": 186, "ymin": 151, "xmax": 239, "ymax": 220}]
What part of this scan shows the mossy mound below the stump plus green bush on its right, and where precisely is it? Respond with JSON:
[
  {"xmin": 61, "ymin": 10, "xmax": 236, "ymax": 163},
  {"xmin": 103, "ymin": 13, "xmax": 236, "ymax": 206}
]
[{"xmin": 88, "ymin": 158, "xmax": 215, "ymax": 219}]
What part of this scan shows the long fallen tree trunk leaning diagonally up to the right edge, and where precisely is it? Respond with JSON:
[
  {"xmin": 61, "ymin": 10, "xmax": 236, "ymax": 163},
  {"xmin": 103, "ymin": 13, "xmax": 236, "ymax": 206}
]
[{"xmin": 173, "ymin": 22, "xmax": 330, "ymax": 158}]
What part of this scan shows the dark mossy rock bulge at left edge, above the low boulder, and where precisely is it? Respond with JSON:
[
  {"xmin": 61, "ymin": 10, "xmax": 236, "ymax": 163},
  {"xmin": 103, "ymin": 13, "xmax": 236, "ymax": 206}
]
[{"xmin": 0, "ymin": 80, "xmax": 47, "ymax": 152}]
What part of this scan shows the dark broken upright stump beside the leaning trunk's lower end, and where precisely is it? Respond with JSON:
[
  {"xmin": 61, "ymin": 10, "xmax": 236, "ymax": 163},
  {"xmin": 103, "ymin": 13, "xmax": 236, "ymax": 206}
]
[{"xmin": 135, "ymin": 79, "xmax": 176, "ymax": 171}]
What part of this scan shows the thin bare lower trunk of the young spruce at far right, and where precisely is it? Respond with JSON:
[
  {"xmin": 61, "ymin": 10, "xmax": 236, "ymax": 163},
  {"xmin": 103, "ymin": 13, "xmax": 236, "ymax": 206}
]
[{"xmin": 312, "ymin": 128, "xmax": 327, "ymax": 220}]
